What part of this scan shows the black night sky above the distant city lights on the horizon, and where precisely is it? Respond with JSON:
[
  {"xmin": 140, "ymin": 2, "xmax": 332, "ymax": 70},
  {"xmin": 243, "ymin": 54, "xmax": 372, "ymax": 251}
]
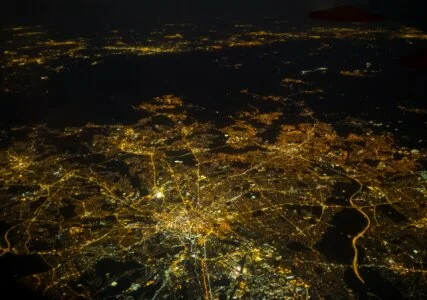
[{"xmin": 0, "ymin": 0, "xmax": 427, "ymax": 30}]
